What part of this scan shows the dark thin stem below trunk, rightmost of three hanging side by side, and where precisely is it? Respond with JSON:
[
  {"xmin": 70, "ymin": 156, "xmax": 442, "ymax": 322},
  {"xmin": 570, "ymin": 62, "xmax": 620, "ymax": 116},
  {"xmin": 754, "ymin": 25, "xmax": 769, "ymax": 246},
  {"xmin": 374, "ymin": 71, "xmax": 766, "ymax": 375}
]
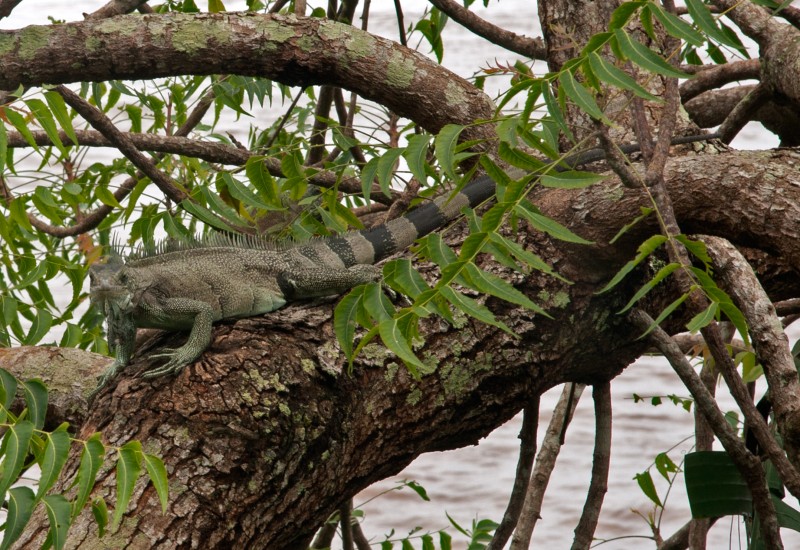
[{"xmin": 572, "ymin": 382, "xmax": 611, "ymax": 550}]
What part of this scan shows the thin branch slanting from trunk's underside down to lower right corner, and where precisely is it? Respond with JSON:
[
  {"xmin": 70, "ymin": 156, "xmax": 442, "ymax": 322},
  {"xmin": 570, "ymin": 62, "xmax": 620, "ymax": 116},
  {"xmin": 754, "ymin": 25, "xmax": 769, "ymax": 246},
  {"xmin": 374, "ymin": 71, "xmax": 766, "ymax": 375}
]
[{"xmin": 629, "ymin": 309, "xmax": 783, "ymax": 550}]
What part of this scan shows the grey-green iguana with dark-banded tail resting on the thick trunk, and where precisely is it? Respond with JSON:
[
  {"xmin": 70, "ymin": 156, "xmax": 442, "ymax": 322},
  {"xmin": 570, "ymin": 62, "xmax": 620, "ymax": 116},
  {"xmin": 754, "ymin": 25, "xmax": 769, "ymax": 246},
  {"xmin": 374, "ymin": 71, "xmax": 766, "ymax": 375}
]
[{"xmin": 89, "ymin": 134, "xmax": 716, "ymax": 389}]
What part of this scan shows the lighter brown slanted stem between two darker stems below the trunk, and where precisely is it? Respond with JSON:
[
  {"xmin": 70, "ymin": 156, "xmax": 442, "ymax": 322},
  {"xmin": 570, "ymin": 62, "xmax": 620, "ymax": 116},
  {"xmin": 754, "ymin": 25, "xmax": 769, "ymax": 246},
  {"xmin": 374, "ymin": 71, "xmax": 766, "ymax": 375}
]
[{"xmin": 511, "ymin": 384, "xmax": 585, "ymax": 550}]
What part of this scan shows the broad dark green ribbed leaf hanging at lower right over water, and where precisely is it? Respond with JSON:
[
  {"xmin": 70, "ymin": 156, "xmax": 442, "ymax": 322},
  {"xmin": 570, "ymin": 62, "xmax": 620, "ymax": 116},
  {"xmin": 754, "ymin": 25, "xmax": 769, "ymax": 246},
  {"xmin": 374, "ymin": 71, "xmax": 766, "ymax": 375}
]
[{"xmin": 683, "ymin": 451, "xmax": 753, "ymax": 518}]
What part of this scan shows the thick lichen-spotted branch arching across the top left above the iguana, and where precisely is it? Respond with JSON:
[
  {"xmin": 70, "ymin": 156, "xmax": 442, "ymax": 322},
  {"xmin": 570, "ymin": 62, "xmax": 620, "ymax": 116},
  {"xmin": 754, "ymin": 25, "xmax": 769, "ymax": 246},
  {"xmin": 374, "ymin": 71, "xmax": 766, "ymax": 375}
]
[{"xmin": 0, "ymin": 13, "xmax": 494, "ymax": 140}]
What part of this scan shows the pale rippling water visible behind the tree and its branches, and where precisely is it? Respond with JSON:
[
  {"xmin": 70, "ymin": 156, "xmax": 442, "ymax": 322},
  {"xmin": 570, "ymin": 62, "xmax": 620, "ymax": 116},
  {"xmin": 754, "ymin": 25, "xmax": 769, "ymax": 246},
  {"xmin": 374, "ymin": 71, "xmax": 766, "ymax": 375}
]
[{"xmin": 0, "ymin": 0, "xmax": 800, "ymax": 550}]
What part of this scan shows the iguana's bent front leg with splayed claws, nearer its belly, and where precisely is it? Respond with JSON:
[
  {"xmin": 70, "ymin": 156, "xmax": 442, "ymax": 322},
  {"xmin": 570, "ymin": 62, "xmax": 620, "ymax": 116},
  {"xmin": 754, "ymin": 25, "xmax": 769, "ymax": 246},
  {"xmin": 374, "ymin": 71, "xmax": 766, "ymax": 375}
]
[{"xmin": 142, "ymin": 298, "xmax": 214, "ymax": 378}]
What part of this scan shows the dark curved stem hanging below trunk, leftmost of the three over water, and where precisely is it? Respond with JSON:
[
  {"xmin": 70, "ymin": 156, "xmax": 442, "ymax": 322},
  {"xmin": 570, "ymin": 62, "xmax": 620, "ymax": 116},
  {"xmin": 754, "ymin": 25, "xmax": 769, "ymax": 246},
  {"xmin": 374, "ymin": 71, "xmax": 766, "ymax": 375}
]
[{"xmin": 486, "ymin": 395, "xmax": 539, "ymax": 550}]
